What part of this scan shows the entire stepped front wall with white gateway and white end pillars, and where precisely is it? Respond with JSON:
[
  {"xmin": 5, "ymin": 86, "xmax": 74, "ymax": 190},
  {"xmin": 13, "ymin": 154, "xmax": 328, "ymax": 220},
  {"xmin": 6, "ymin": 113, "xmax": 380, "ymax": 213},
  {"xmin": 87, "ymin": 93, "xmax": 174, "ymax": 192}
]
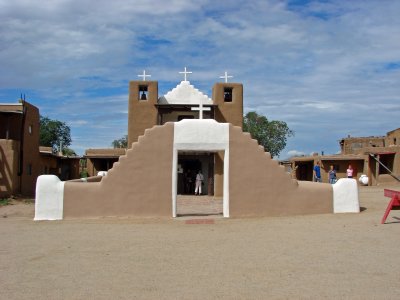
[{"xmin": 35, "ymin": 120, "xmax": 352, "ymax": 220}]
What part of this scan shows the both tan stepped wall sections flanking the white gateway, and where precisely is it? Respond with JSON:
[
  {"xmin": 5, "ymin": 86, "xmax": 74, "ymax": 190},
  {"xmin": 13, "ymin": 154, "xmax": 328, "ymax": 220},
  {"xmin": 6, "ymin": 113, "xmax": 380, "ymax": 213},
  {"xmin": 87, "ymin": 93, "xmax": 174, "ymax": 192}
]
[{"xmin": 64, "ymin": 123, "xmax": 333, "ymax": 218}]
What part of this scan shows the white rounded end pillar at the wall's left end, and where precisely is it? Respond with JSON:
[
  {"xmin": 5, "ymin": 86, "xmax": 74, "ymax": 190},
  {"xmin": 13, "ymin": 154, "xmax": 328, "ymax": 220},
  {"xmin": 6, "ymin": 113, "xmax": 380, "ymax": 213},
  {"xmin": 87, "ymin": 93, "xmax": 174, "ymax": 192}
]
[{"xmin": 34, "ymin": 175, "xmax": 64, "ymax": 221}]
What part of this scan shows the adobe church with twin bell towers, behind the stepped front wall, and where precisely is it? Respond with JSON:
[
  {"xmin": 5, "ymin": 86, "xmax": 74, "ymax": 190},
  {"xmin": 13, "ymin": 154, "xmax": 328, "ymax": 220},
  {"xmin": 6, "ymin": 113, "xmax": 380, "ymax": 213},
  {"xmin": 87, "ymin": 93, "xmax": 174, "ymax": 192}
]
[{"xmin": 85, "ymin": 69, "xmax": 243, "ymax": 196}]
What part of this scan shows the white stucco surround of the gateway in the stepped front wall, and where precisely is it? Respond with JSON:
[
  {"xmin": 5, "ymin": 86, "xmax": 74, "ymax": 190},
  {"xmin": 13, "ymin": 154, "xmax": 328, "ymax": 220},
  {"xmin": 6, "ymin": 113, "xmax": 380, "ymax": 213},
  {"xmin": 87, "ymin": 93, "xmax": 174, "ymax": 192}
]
[{"xmin": 172, "ymin": 119, "xmax": 229, "ymax": 217}]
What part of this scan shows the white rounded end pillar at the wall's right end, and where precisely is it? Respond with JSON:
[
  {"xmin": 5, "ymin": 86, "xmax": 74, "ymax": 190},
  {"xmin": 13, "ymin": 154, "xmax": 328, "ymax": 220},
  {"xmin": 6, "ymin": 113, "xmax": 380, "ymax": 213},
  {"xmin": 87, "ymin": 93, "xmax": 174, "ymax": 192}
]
[{"xmin": 332, "ymin": 178, "xmax": 360, "ymax": 213}]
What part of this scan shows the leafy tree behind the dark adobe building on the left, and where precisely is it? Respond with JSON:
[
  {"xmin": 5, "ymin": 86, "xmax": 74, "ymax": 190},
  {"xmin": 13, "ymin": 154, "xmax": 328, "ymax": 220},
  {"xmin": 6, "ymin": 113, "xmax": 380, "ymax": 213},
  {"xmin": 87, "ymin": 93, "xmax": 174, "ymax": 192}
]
[{"xmin": 39, "ymin": 116, "xmax": 71, "ymax": 152}]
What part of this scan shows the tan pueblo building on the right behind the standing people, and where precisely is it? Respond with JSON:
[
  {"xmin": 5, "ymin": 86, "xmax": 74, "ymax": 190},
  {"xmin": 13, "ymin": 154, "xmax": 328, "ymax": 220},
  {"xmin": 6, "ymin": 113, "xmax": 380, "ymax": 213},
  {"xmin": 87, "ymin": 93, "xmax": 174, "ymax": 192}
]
[{"xmin": 290, "ymin": 128, "xmax": 400, "ymax": 185}]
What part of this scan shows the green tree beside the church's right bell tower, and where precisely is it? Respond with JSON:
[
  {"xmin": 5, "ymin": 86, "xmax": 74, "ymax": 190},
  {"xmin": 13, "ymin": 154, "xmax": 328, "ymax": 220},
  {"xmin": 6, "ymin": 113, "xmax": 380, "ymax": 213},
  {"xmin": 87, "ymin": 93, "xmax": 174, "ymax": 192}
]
[{"xmin": 243, "ymin": 111, "xmax": 294, "ymax": 157}]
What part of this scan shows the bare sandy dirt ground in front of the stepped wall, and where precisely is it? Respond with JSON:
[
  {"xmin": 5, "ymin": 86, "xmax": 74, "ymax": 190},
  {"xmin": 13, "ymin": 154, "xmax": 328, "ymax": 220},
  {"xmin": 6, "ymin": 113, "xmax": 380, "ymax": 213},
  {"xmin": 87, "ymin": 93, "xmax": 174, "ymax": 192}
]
[{"xmin": 0, "ymin": 185, "xmax": 400, "ymax": 299}]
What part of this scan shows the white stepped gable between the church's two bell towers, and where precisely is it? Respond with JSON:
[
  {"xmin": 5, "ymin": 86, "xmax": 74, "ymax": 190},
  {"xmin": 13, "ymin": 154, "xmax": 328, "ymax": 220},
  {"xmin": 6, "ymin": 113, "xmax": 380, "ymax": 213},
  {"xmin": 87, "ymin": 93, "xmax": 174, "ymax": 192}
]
[{"xmin": 158, "ymin": 81, "xmax": 213, "ymax": 105}]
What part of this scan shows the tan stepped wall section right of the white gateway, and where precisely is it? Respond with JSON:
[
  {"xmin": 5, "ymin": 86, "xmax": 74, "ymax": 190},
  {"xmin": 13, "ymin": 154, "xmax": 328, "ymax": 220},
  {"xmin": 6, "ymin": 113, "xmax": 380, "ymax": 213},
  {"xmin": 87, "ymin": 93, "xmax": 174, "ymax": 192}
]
[{"xmin": 229, "ymin": 126, "xmax": 333, "ymax": 216}]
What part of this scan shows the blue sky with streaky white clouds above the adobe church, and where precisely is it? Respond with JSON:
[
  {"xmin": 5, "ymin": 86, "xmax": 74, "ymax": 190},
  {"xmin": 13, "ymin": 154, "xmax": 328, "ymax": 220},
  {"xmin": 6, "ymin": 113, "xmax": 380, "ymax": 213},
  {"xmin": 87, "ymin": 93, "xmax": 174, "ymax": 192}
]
[{"xmin": 0, "ymin": 0, "xmax": 400, "ymax": 159}]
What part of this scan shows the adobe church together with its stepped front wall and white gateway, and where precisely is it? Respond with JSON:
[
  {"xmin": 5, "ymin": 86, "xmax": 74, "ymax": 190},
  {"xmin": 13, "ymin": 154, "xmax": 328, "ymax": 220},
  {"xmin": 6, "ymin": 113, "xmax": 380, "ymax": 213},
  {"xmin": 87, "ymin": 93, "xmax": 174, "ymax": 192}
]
[{"xmin": 35, "ymin": 68, "xmax": 359, "ymax": 220}]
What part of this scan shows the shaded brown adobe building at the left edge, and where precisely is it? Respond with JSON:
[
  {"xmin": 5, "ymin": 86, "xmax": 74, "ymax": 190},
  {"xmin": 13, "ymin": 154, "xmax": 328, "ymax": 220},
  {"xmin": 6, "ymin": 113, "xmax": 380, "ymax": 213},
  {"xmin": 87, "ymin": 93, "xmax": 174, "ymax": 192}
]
[{"xmin": 0, "ymin": 97, "xmax": 79, "ymax": 197}]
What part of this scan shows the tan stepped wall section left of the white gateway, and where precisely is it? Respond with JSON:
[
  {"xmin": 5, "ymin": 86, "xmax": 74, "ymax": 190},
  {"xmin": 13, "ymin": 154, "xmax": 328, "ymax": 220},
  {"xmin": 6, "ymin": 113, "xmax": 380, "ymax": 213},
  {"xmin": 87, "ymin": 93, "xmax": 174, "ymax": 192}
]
[{"xmin": 64, "ymin": 123, "xmax": 174, "ymax": 218}]
